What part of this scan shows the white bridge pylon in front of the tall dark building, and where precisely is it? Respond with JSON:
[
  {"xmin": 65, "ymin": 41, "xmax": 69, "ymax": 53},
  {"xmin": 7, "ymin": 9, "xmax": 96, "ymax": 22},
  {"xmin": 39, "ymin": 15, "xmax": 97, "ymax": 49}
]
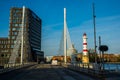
[{"xmin": 21, "ymin": 6, "xmax": 25, "ymax": 64}]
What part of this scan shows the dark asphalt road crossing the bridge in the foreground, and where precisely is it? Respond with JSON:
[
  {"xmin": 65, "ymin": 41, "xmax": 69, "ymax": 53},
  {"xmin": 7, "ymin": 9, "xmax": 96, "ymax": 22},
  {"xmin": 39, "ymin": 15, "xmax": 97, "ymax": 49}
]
[{"xmin": 0, "ymin": 64, "xmax": 96, "ymax": 80}]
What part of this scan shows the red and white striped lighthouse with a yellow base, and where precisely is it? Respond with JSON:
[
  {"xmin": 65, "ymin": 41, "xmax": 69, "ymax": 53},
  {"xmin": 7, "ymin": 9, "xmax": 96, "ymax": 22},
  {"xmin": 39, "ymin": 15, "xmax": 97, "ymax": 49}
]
[{"xmin": 82, "ymin": 33, "xmax": 89, "ymax": 63}]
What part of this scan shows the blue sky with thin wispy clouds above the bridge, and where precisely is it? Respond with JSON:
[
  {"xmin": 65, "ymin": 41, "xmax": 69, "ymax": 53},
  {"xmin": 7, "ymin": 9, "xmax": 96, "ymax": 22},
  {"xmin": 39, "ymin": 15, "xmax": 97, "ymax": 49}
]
[{"xmin": 0, "ymin": 0, "xmax": 120, "ymax": 56}]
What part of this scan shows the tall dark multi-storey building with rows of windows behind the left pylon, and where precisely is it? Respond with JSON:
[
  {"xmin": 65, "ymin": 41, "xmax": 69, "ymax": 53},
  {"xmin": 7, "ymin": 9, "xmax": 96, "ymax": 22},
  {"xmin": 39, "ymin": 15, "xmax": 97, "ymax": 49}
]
[{"xmin": 0, "ymin": 7, "xmax": 44, "ymax": 62}]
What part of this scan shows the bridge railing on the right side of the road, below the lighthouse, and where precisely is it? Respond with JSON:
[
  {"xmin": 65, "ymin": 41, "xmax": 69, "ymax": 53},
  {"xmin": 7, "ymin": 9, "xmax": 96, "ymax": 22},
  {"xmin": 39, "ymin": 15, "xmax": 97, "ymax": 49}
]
[{"xmin": 62, "ymin": 63, "xmax": 120, "ymax": 77}]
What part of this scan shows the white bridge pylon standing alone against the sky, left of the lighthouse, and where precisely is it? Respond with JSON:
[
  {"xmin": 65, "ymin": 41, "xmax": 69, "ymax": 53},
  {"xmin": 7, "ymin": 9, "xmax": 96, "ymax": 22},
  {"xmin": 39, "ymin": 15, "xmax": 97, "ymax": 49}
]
[{"xmin": 64, "ymin": 8, "xmax": 67, "ymax": 64}]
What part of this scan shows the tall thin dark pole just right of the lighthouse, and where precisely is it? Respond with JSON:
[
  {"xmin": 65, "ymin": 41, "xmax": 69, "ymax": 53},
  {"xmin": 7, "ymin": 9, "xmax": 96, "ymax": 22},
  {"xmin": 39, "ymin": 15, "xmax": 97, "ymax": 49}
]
[{"xmin": 93, "ymin": 3, "xmax": 97, "ymax": 63}]
